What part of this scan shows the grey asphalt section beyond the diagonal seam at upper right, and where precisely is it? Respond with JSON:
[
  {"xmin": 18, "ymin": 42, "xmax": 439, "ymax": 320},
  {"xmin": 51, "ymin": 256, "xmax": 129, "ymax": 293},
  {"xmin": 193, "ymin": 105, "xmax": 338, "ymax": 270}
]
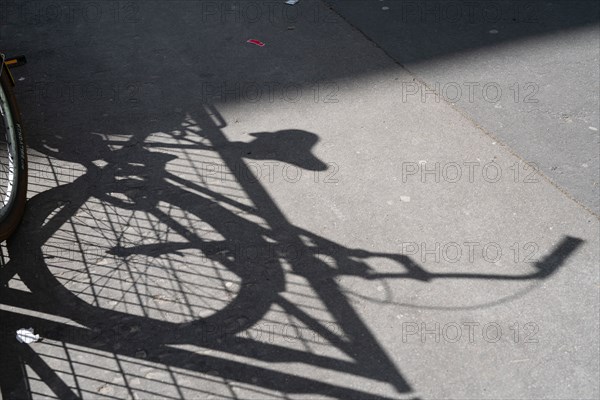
[{"xmin": 328, "ymin": 0, "xmax": 600, "ymax": 215}]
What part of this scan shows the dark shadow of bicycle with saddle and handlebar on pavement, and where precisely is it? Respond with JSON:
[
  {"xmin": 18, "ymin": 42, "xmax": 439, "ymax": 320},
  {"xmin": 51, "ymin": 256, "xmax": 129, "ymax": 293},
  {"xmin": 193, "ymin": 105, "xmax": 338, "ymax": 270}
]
[{"xmin": 0, "ymin": 101, "xmax": 581, "ymax": 399}]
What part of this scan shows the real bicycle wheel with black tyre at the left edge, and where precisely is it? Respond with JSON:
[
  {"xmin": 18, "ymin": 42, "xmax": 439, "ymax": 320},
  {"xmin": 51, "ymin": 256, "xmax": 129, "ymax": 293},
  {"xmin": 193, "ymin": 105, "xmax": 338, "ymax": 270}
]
[{"xmin": 0, "ymin": 66, "xmax": 27, "ymax": 241}]
